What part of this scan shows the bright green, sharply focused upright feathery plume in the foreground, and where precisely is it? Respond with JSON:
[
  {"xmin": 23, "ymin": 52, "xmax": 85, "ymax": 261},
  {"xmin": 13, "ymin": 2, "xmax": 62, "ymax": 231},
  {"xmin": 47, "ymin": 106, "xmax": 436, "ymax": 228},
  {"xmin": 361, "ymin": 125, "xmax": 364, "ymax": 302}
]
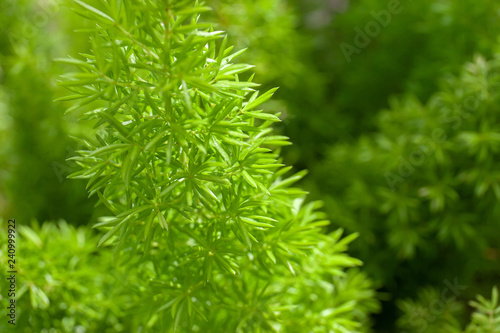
[{"xmin": 59, "ymin": 0, "xmax": 377, "ymax": 332}]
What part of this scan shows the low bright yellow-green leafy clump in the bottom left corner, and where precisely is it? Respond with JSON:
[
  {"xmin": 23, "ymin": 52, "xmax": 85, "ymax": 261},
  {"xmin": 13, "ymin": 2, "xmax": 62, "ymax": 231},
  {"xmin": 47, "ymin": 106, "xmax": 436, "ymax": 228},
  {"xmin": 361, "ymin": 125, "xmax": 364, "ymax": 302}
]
[{"xmin": 0, "ymin": 220, "xmax": 138, "ymax": 332}]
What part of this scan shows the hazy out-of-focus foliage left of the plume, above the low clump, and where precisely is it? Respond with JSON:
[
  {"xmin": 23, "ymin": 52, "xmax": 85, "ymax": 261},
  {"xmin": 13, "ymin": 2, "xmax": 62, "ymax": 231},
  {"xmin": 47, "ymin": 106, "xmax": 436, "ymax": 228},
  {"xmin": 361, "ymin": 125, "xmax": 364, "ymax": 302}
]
[{"xmin": 0, "ymin": 0, "xmax": 92, "ymax": 224}]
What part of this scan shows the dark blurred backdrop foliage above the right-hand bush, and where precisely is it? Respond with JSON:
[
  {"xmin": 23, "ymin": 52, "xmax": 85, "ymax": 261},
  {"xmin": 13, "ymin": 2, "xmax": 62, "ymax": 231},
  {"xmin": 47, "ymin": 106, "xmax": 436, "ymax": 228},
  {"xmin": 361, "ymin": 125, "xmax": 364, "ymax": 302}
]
[{"xmin": 215, "ymin": 0, "xmax": 500, "ymax": 165}]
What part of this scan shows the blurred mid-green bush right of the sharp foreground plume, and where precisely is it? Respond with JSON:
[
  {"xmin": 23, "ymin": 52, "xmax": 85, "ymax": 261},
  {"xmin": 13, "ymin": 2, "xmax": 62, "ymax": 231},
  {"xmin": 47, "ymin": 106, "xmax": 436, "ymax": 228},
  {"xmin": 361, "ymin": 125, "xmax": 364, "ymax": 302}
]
[{"xmin": 316, "ymin": 57, "xmax": 500, "ymax": 279}]
